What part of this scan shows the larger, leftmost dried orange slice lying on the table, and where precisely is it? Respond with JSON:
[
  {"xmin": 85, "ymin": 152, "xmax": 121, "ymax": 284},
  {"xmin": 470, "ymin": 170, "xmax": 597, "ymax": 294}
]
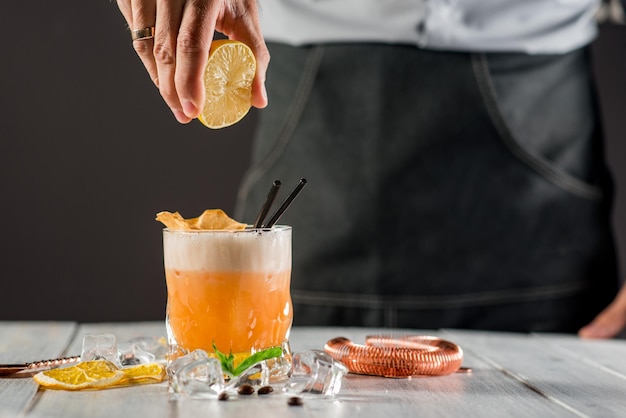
[{"xmin": 33, "ymin": 360, "xmax": 124, "ymax": 390}]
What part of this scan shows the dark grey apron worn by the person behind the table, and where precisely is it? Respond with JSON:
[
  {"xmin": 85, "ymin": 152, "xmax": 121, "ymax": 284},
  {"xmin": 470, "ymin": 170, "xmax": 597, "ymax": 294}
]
[{"xmin": 236, "ymin": 44, "xmax": 618, "ymax": 332}]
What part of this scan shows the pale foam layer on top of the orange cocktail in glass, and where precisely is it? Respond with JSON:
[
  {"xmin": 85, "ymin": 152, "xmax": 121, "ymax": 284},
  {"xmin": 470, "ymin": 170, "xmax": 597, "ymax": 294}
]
[{"xmin": 163, "ymin": 226, "xmax": 291, "ymax": 272}]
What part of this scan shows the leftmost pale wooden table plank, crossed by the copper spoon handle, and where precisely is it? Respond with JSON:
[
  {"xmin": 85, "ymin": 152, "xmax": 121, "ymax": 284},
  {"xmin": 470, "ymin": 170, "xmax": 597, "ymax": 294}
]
[{"xmin": 0, "ymin": 321, "xmax": 80, "ymax": 416}]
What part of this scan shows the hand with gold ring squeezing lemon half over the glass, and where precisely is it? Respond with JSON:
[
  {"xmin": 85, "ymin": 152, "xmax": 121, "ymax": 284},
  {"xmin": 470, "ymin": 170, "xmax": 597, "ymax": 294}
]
[{"xmin": 117, "ymin": 0, "xmax": 270, "ymax": 123}]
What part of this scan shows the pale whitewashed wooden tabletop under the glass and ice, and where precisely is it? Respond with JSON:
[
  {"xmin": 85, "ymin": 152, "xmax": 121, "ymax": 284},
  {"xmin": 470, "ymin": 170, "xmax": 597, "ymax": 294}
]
[{"xmin": 0, "ymin": 322, "xmax": 626, "ymax": 418}]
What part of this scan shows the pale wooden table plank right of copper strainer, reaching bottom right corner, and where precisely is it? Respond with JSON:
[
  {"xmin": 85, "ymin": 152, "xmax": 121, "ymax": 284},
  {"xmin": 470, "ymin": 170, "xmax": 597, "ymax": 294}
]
[{"xmin": 446, "ymin": 330, "xmax": 626, "ymax": 417}]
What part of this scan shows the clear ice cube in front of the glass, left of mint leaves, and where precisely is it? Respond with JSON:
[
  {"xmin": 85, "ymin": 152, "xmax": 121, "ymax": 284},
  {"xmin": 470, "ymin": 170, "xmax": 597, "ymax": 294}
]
[{"xmin": 167, "ymin": 350, "xmax": 224, "ymax": 399}]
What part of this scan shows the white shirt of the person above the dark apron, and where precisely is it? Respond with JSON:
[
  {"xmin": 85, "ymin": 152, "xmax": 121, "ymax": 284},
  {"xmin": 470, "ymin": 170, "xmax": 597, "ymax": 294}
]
[{"xmin": 260, "ymin": 0, "xmax": 600, "ymax": 54}]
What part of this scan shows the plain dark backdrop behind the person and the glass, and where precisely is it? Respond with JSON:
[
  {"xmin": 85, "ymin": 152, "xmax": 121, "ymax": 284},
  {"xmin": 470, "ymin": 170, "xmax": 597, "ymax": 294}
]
[{"xmin": 0, "ymin": 0, "xmax": 626, "ymax": 321}]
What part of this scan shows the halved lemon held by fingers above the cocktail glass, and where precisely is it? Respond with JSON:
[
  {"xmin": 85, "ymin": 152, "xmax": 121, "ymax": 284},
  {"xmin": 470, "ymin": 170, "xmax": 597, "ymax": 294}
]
[{"xmin": 198, "ymin": 39, "xmax": 256, "ymax": 129}]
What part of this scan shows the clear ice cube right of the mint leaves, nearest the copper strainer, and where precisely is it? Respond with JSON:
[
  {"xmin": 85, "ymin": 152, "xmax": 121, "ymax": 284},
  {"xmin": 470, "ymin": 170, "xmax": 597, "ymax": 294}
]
[{"xmin": 283, "ymin": 350, "xmax": 348, "ymax": 396}]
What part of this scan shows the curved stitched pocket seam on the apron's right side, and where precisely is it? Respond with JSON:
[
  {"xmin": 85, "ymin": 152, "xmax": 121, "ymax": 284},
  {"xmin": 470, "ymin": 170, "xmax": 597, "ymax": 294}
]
[{"xmin": 472, "ymin": 54, "xmax": 603, "ymax": 200}]
